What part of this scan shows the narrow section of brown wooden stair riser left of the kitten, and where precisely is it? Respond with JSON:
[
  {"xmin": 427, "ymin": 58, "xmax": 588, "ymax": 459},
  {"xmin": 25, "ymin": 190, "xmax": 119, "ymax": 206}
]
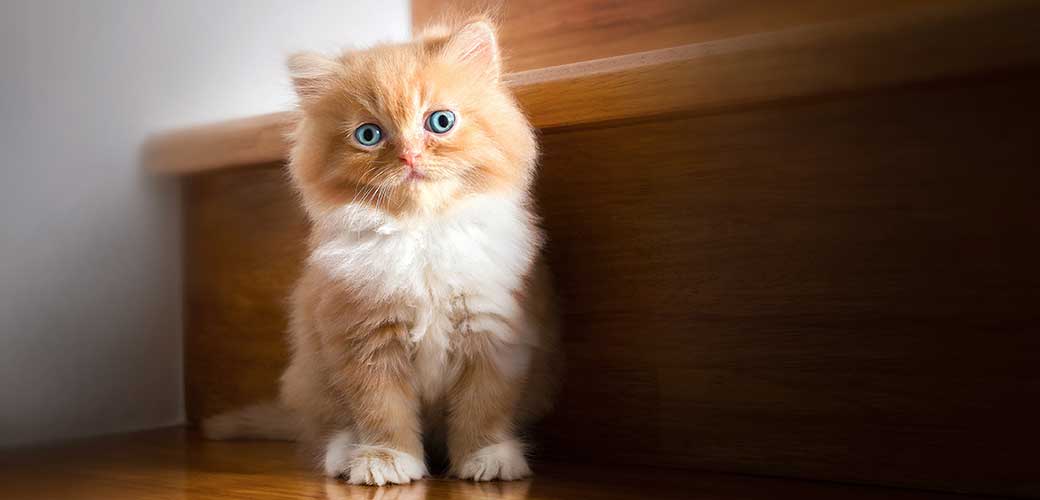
[{"xmin": 182, "ymin": 164, "xmax": 309, "ymax": 420}]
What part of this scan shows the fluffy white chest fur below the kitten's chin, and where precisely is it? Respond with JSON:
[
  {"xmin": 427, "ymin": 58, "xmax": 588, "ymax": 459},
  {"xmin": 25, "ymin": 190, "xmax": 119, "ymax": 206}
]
[{"xmin": 310, "ymin": 194, "xmax": 541, "ymax": 344}]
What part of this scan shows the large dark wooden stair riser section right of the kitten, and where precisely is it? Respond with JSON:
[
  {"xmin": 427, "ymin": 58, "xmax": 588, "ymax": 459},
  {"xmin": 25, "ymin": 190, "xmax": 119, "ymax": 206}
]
[{"xmin": 539, "ymin": 76, "xmax": 1040, "ymax": 496}]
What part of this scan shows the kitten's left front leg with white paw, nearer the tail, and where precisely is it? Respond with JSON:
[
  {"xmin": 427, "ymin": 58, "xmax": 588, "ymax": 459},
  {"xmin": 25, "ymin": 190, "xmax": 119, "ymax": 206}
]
[{"xmin": 326, "ymin": 324, "xmax": 426, "ymax": 485}]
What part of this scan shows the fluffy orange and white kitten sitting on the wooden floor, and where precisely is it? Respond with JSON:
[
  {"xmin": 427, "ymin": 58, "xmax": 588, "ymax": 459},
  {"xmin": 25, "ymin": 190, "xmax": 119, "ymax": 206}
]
[{"xmin": 205, "ymin": 20, "xmax": 561, "ymax": 484}]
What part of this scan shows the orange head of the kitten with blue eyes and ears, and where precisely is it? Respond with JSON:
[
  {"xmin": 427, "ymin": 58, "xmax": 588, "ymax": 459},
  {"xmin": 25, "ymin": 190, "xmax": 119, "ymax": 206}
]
[{"xmin": 289, "ymin": 21, "xmax": 537, "ymax": 216}]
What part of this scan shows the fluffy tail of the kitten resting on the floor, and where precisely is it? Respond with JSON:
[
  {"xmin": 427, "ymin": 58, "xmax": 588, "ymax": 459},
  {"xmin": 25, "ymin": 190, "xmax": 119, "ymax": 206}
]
[{"xmin": 202, "ymin": 401, "xmax": 302, "ymax": 441}]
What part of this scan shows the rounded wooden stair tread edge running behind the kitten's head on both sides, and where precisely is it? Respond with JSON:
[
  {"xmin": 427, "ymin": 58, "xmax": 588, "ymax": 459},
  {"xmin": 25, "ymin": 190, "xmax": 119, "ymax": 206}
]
[{"xmin": 144, "ymin": 0, "xmax": 1040, "ymax": 174}]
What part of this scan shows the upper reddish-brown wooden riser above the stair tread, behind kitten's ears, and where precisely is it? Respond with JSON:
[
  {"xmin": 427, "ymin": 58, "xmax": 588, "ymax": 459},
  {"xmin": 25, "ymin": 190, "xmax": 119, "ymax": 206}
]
[{"xmin": 412, "ymin": 0, "xmax": 939, "ymax": 72}]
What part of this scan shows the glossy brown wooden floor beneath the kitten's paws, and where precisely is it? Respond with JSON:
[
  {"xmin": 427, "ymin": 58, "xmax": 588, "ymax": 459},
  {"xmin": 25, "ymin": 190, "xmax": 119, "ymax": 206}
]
[{"xmin": 0, "ymin": 428, "xmax": 1006, "ymax": 500}]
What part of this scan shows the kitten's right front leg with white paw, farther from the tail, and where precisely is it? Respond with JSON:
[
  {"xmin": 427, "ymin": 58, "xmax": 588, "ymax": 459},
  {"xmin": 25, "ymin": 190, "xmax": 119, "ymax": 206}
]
[{"xmin": 447, "ymin": 332, "xmax": 530, "ymax": 481}]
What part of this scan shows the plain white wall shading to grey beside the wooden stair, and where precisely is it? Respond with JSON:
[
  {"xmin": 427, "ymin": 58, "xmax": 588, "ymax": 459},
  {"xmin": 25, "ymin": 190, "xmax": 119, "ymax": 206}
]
[{"xmin": 0, "ymin": 0, "xmax": 409, "ymax": 446}]
